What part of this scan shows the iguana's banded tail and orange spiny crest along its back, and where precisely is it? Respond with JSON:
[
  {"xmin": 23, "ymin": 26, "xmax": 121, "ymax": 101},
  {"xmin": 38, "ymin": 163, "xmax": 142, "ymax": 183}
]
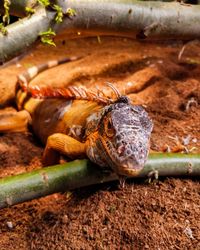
[{"xmin": 17, "ymin": 57, "xmax": 121, "ymax": 109}]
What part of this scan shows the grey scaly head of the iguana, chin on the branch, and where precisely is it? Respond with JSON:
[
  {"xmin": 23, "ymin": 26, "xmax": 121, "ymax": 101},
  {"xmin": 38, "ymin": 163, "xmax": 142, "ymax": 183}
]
[{"xmin": 86, "ymin": 96, "xmax": 153, "ymax": 176}]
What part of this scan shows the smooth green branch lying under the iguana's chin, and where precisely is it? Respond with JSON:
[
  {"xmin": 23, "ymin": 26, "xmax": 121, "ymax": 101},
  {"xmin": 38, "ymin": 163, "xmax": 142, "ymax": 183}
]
[{"xmin": 0, "ymin": 154, "xmax": 200, "ymax": 208}]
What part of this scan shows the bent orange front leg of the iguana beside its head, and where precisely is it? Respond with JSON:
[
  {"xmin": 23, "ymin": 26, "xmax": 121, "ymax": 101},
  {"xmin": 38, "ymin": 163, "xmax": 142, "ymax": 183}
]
[{"xmin": 43, "ymin": 133, "xmax": 86, "ymax": 166}]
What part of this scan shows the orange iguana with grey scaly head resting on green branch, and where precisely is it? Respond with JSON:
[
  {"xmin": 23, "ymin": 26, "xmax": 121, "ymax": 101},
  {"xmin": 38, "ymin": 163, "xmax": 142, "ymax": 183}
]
[{"xmin": 0, "ymin": 58, "xmax": 153, "ymax": 176}]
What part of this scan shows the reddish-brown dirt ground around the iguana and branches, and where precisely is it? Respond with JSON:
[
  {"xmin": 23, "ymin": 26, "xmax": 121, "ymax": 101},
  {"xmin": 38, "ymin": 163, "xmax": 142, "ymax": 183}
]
[{"xmin": 0, "ymin": 37, "xmax": 200, "ymax": 250}]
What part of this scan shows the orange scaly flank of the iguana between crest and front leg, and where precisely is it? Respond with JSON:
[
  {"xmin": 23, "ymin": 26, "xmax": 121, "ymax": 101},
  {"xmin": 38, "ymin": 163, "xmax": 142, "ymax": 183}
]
[{"xmin": 33, "ymin": 99, "xmax": 103, "ymax": 144}]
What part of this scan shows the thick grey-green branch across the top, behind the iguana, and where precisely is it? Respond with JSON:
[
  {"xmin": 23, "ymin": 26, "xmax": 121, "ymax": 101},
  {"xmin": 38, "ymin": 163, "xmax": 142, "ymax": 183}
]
[{"xmin": 0, "ymin": 0, "xmax": 200, "ymax": 63}]
